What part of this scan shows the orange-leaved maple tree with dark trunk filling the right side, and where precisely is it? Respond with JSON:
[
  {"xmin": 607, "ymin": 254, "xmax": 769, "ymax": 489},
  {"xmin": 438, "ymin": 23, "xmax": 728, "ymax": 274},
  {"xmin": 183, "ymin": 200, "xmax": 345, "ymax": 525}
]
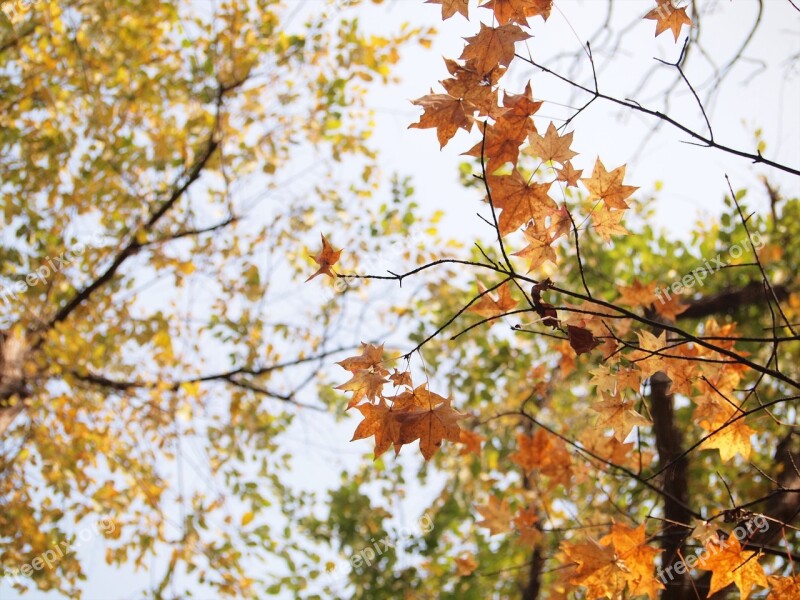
[{"xmin": 306, "ymin": 0, "xmax": 800, "ymax": 599}]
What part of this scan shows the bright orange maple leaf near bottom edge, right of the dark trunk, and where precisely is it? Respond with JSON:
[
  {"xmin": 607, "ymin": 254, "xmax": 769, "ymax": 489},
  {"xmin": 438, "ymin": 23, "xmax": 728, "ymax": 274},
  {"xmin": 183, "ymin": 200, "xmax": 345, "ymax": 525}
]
[{"xmin": 697, "ymin": 536, "xmax": 769, "ymax": 599}]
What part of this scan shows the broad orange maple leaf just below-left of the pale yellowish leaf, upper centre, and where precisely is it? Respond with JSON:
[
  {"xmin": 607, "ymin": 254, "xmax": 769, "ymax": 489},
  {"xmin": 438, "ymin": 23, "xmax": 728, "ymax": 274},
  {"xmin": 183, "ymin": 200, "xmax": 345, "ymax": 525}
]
[{"xmin": 487, "ymin": 169, "xmax": 558, "ymax": 236}]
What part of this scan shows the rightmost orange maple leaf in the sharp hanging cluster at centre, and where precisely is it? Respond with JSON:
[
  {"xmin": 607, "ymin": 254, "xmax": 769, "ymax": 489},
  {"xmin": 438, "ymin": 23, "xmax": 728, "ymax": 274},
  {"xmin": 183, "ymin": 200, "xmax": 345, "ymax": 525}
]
[{"xmin": 396, "ymin": 388, "xmax": 464, "ymax": 460}]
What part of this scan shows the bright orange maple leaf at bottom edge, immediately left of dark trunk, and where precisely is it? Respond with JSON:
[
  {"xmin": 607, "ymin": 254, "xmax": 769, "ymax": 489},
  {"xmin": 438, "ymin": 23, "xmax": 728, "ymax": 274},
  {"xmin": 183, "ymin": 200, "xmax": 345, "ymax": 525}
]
[{"xmin": 600, "ymin": 523, "xmax": 664, "ymax": 600}]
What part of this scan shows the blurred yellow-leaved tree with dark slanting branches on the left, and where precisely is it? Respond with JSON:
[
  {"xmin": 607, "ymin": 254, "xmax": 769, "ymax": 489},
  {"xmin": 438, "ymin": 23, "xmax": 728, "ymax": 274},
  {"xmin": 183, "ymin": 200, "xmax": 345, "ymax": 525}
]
[{"xmin": 0, "ymin": 0, "xmax": 429, "ymax": 597}]
